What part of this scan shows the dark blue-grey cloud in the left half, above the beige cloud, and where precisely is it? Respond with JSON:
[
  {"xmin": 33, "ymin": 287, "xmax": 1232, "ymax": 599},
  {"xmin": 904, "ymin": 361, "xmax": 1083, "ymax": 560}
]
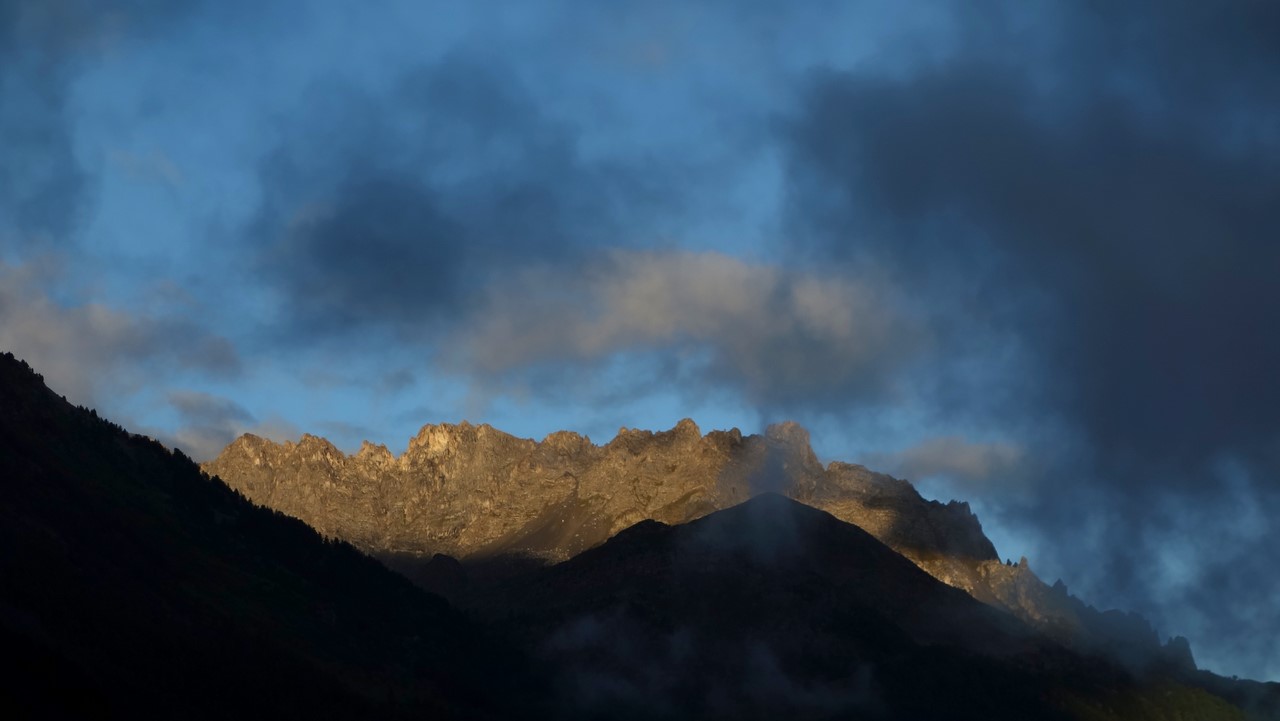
[{"xmin": 244, "ymin": 55, "xmax": 675, "ymax": 334}]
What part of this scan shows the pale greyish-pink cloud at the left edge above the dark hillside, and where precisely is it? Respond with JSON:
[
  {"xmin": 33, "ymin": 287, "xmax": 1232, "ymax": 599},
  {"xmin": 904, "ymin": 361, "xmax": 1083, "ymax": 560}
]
[{"xmin": 0, "ymin": 263, "xmax": 241, "ymax": 406}]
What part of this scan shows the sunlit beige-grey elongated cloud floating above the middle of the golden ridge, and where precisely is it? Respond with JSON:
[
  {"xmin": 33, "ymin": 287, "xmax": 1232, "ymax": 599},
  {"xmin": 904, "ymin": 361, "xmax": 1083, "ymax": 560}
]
[{"xmin": 445, "ymin": 251, "xmax": 925, "ymax": 407}]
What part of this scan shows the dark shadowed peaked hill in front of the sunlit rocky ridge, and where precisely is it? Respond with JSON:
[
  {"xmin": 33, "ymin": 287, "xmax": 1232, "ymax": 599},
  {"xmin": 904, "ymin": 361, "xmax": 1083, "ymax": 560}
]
[{"xmin": 472, "ymin": 494, "xmax": 1240, "ymax": 721}]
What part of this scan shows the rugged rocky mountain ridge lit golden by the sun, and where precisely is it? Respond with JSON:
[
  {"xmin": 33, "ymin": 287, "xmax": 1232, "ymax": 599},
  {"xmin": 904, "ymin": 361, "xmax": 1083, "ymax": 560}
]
[{"xmin": 204, "ymin": 419, "xmax": 1194, "ymax": 668}]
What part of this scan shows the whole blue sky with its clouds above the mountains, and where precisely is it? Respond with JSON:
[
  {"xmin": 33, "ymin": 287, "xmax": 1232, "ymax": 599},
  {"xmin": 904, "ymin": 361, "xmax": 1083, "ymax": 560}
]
[{"xmin": 0, "ymin": 0, "xmax": 1280, "ymax": 679}]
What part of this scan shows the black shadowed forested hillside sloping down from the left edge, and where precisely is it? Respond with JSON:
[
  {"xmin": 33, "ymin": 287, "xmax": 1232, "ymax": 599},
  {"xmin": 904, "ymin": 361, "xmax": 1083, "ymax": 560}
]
[{"xmin": 0, "ymin": 355, "xmax": 530, "ymax": 718}]
